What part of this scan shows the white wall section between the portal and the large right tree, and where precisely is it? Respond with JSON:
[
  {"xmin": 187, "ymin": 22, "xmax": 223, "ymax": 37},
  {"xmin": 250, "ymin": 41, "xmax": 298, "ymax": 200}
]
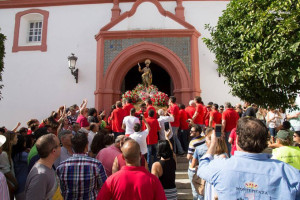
[{"xmin": 183, "ymin": 1, "xmax": 240, "ymax": 105}]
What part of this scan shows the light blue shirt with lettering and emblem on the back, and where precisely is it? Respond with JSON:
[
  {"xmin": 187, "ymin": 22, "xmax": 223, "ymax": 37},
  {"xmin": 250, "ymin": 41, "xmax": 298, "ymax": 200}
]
[{"xmin": 197, "ymin": 151, "xmax": 300, "ymax": 200}]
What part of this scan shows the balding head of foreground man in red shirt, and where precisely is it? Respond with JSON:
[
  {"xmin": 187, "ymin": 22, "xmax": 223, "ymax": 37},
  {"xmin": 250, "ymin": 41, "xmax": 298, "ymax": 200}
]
[{"xmin": 121, "ymin": 140, "xmax": 141, "ymax": 166}]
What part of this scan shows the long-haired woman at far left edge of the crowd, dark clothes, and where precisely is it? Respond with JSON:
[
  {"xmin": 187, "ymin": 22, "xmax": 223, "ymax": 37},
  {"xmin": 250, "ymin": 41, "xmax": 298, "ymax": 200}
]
[{"xmin": 0, "ymin": 131, "xmax": 18, "ymax": 200}]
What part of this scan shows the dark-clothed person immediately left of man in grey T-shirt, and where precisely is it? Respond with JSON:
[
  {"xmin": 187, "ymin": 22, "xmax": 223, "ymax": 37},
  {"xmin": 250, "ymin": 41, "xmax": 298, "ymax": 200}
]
[{"xmin": 12, "ymin": 135, "xmax": 28, "ymax": 200}]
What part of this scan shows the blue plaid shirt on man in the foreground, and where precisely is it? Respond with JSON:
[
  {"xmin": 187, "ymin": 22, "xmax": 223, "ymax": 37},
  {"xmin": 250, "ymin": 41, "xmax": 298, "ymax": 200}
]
[{"xmin": 56, "ymin": 154, "xmax": 107, "ymax": 200}]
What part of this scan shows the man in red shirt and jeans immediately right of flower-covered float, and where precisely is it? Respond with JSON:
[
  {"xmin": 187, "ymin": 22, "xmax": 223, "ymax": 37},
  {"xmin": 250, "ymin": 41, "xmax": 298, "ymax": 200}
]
[{"xmin": 168, "ymin": 96, "xmax": 184, "ymax": 155}]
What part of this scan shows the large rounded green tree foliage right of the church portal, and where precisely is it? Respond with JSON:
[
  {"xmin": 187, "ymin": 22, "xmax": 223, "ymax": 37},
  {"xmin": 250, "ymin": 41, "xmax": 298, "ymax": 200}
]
[{"xmin": 203, "ymin": 0, "xmax": 300, "ymax": 108}]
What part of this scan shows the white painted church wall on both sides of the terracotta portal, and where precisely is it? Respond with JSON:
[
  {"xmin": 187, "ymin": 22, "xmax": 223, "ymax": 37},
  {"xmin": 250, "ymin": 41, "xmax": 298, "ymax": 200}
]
[{"xmin": 0, "ymin": 1, "xmax": 239, "ymax": 129}]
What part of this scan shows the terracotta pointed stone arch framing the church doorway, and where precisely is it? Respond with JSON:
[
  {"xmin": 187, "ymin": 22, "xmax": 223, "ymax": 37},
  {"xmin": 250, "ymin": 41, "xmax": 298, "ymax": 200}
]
[{"xmin": 95, "ymin": 42, "xmax": 195, "ymax": 110}]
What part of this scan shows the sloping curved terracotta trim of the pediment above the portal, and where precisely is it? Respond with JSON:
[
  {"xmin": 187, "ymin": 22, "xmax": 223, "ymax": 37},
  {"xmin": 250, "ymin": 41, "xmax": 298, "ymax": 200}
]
[{"xmin": 100, "ymin": 0, "xmax": 194, "ymax": 31}]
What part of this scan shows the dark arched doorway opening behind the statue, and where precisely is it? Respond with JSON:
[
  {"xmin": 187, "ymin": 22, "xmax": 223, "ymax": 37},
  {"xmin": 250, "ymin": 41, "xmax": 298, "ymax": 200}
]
[{"xmin": 121, "ymin": 62, "xmax": 174, "ymax": 96}]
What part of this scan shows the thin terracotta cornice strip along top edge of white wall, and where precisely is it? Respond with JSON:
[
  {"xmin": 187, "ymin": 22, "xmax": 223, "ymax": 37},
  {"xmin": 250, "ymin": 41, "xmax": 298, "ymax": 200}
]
[{"xmin": 0, "ymin": 0, "xmax": 230, "ymax": 8}]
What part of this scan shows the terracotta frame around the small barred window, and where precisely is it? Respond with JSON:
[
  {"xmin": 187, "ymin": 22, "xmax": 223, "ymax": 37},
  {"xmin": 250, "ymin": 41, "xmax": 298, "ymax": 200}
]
[{"xmin": 12, "ymin": 9, "xmax": 49, "ymax": 52}]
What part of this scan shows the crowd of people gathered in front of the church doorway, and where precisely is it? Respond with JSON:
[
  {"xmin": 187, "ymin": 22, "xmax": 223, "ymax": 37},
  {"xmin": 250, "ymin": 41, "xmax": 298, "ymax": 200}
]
[{"xmin": 0, "ymin": 96, "xmax": 300, "ymax": 200}]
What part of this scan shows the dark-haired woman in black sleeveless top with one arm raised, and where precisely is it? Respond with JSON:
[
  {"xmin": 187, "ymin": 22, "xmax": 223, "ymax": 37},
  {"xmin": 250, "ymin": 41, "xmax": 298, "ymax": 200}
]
[{"xmin": 151, "ymin": 130, "xmax": 177, "ymax": 200}]
